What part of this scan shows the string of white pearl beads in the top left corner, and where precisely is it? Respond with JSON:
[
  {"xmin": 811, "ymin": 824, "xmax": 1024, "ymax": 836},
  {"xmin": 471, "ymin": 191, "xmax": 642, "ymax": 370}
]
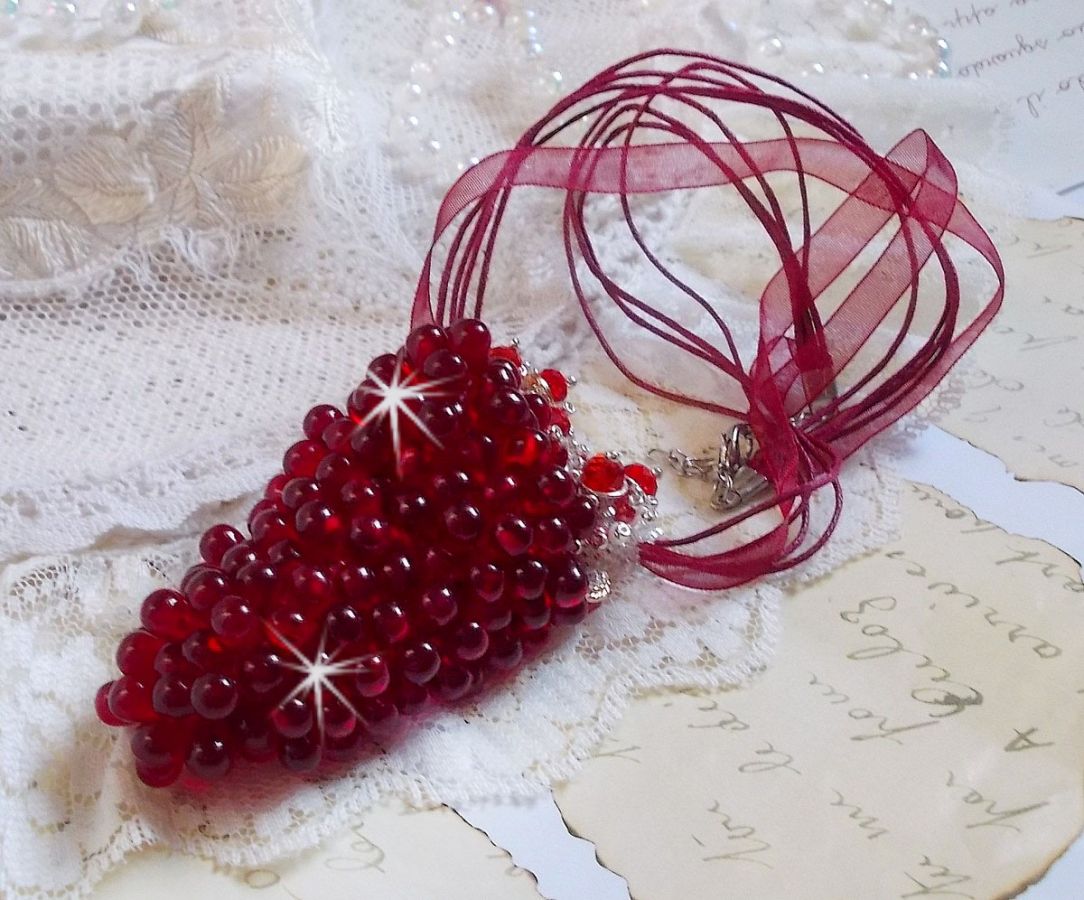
[{"xmin": 0, "ymin": 0, "xmax": 183, "ymax": 46}]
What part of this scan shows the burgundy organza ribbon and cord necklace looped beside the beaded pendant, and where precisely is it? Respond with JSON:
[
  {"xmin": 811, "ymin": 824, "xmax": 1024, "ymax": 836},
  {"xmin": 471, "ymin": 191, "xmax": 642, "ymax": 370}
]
[{"xmin": 413, "ymin": 50, "xmax": 1004, "ymax": 589}]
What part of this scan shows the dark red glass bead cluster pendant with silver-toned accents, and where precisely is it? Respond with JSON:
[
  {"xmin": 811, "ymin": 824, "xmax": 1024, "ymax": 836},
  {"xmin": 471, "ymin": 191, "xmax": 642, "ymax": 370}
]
[{"xmin": 95, "ymin": 319, "xmax": 656, "ymax": 786}]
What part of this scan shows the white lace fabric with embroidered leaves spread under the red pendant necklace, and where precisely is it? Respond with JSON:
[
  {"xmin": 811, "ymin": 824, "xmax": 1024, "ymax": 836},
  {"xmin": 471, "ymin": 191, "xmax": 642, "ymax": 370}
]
[{"xmin": 0, "ymin": 0, "xmax": 1005, "ymax": 898}]
